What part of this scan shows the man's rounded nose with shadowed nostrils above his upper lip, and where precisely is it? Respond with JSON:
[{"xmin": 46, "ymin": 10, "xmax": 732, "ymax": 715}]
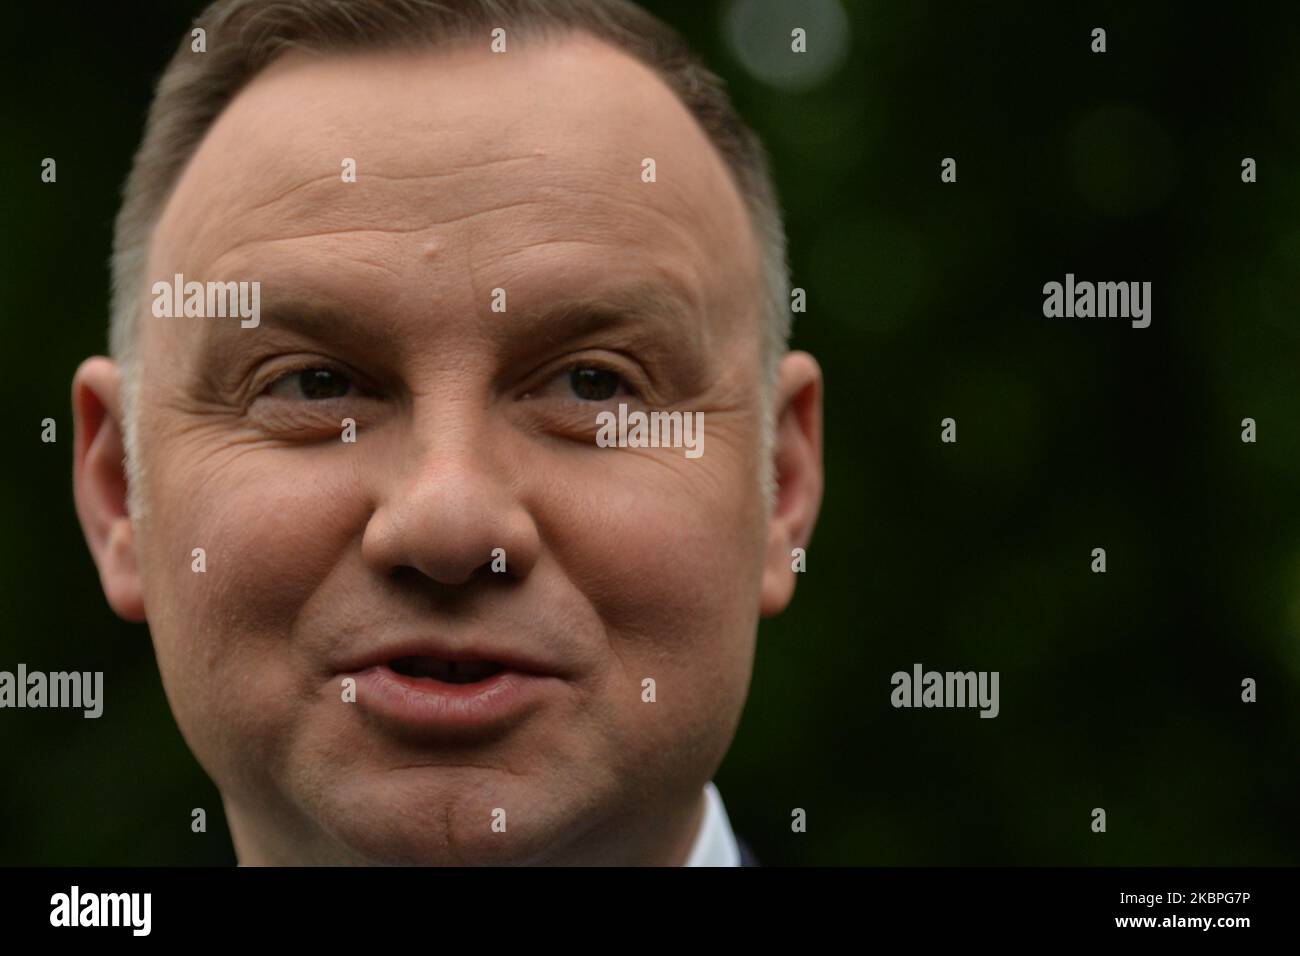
[{"xmin": 361, "ymin": 421, "xmax": 541, "ymax": 585}]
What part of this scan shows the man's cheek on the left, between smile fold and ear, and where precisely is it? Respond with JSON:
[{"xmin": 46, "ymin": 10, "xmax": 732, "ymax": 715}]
[{"xmin": 137, "ymin": 450, "xmax": 360, "ymax": 779}]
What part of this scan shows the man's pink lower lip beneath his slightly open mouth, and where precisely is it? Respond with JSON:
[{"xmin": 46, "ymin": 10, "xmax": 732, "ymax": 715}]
[{"xmin": 350, "ymin": 665, "xmax": 558, "ymax": 731}]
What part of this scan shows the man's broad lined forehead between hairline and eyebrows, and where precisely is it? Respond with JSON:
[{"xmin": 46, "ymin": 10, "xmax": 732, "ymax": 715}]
[{"xmin": 150, "ymin": 35, "xmax": 759, "ymax": 345}]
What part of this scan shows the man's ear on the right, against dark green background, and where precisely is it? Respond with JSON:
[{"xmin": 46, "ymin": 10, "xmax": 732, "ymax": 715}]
[{"xmin": 759, "ymin": 352, "xmax": 823, "ymax": 618}]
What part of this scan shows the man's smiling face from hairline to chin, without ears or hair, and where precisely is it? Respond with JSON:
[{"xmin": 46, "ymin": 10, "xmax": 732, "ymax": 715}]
[{"xmin": 76, "ymin": 38, "xmax": 816, "ymax": 862}]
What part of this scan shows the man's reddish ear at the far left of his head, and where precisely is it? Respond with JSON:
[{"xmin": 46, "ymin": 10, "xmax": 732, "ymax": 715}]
[{"xmin": 73, "ymin": 355, "xmax": 144, "ymax": 622}]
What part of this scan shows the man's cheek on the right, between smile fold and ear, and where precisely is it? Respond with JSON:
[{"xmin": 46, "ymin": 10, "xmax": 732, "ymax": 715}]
[{"xmin": 533, "ymin": 436, "xmax": 764, "ymax": 757}]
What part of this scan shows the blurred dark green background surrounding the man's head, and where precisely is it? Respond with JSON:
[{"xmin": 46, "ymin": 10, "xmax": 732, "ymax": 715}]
[{"xmin": 0, "ymin": 0, "xmax": 1300, "ymax": 864}]
